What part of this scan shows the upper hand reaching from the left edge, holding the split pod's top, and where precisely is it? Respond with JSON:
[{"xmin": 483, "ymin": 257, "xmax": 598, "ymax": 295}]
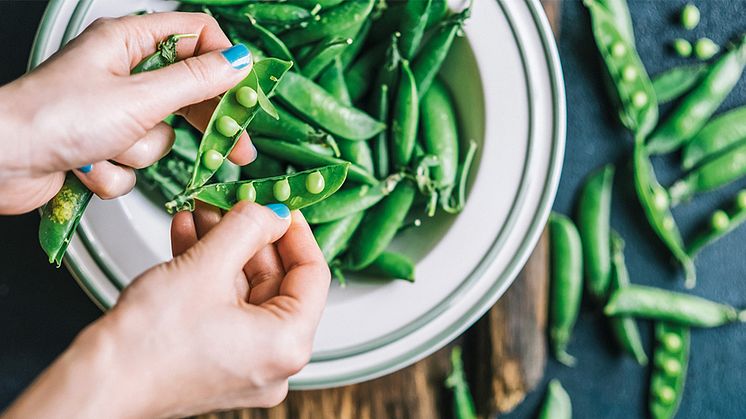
[{"xmin": 0, "ymin": 13, "xmax": 256, "ymax": 214}]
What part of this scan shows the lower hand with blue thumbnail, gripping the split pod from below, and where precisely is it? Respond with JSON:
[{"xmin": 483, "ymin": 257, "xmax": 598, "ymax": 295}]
[{"xmin": 2, "ymin": 202, "xmax": 330, "ymax": 417}]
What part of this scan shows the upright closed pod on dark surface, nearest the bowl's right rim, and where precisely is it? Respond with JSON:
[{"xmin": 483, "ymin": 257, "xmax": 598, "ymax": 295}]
[{"xmin": 549, "ymin": 213, "xmax": 583, "ymax": 366}]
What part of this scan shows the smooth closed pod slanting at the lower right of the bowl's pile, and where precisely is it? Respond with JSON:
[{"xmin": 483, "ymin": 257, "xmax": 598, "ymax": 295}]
[{"xmin": 345, "ymin": 181, "xmax": 417, "ymax": 270}]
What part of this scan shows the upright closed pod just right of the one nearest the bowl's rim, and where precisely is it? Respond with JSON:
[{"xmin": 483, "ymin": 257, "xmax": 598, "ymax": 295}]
[{"xmin": 578, "ymin": 164, "xmax": 614, "ymax": 301}]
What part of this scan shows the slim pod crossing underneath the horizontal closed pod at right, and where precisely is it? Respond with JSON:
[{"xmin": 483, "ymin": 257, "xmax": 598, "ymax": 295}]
[{"xmin": 610, "ymin": 232, "xmax": 648, "ymax": 366}]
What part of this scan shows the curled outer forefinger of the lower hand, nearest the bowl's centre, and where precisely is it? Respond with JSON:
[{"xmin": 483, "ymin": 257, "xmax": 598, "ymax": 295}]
[{"xmin": 268, "ymin": 211, "xmax": 331, "ymax": 331}]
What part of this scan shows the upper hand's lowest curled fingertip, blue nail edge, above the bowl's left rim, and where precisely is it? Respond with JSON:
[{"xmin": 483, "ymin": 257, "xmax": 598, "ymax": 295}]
[{"xmin": 73, "ymin": 161, "xmax": 136, "ymax": 199}]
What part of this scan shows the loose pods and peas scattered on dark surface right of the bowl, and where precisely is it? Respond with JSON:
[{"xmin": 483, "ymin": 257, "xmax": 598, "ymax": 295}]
[{"xmin": 541, "ymin": 0, "xmax": 746, "ymax": 419}]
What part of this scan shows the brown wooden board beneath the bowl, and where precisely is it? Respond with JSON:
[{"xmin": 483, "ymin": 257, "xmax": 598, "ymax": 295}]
[{"xmin": 201, "ymin": 0, "xmax": 560, "ymax": 419}]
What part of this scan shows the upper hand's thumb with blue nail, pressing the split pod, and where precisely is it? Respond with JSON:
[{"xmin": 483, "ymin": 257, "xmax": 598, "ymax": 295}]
[{"xmin": 129, "ymin": 44, "xmax": 253, "ymax": 121}]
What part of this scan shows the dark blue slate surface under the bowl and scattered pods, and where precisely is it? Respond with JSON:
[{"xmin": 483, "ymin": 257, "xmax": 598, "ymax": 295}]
[{"xmin": 0, "ymin": 0, "xmax": 746, "ymax": 418}]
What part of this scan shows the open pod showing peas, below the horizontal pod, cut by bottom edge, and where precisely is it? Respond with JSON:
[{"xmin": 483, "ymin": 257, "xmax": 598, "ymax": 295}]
[{"xmin": 648, "ymin": 322, "xmax": 691, "ymax": 419}]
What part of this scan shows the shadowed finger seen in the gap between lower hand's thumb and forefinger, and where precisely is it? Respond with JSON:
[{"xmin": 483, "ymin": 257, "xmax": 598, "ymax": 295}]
[{"xmin": 244, "ymin": 244, "xmax": 285, "ymax": 305}]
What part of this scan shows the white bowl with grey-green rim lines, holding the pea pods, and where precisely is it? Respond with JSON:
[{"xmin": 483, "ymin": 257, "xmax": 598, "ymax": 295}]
[{"xmin": 30, "ymin": 0, "xmax": 565, "ymax": 389}]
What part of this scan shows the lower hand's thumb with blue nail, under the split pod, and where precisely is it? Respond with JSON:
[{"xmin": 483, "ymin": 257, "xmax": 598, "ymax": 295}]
[{"xmin": 187, "ymin": 201, "xmax": 290, "ymax": 281}]
